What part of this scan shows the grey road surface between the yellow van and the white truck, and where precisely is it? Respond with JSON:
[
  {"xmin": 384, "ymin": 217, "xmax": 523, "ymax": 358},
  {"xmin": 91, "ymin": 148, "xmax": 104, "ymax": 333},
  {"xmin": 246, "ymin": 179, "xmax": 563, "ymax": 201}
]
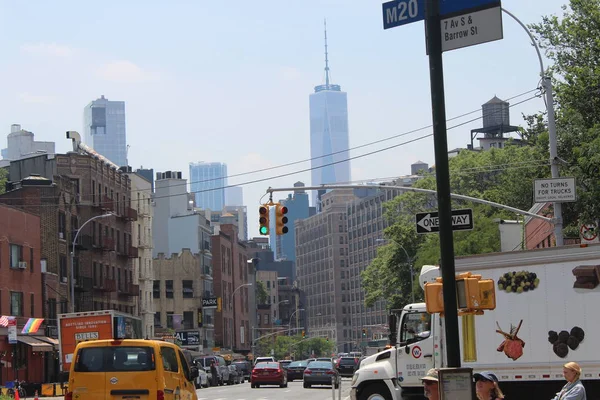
[{"xmin": 37, "ymin": 378, "xmax": 350, "ymax": 400}]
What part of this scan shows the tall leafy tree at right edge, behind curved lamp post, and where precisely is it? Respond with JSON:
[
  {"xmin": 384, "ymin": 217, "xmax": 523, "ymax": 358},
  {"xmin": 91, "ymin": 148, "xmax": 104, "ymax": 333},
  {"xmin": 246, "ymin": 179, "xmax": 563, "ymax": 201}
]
[{"xmin": 530, "ymin": 0, "xmax": 600, "ymax": 227}]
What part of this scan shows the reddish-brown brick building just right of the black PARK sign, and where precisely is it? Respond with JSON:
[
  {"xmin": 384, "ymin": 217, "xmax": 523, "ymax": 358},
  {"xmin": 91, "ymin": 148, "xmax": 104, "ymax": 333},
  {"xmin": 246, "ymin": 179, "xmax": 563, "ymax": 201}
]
[{"xmin": 211, "ymin": 224, "xmax": 250, "ymax": 353}]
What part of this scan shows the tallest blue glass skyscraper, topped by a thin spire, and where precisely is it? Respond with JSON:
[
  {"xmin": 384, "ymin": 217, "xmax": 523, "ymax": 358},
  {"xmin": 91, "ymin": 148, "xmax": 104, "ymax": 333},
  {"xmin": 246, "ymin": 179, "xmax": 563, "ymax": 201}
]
[{"xmin": 309, "ymin": 21, "xmax": 350, "ymax": 210}]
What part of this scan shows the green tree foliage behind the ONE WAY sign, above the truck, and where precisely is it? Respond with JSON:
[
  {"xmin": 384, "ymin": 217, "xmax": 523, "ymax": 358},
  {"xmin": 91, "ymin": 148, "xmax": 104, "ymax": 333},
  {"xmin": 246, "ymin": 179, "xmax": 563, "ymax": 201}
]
[{"xmin": 361, "ymin": 145, "xmax": 550, "ymax": 309}]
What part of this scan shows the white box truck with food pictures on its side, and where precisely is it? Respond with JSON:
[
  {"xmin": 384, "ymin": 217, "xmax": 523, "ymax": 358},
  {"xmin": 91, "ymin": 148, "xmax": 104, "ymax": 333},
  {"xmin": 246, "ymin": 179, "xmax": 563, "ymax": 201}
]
[{"xmin": 351, "ymin": 244, "xmax": 600, "ymax": 400}]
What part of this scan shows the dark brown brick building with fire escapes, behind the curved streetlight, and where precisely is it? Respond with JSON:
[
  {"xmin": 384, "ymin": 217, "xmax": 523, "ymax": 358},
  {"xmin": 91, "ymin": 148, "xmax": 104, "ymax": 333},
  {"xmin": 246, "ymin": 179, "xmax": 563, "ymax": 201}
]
[{"xmin": 6, "ymin": 152, "xmax": 139, "ymax": 315}]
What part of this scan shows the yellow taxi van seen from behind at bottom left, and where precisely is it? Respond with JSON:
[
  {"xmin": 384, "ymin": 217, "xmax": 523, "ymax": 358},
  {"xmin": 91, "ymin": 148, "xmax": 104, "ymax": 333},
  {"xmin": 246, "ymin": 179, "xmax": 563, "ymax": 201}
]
[{"xmin": 65, "ymin": 339, "xmax": 198, "ymax": 400}]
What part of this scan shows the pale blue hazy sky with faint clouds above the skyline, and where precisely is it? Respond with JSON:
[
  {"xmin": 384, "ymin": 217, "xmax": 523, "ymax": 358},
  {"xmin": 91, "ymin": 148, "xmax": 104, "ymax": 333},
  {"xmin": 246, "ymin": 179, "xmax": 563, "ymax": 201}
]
[{"xmin": 0, "ymin": 0, "xmax": 567, "ymax": 237}]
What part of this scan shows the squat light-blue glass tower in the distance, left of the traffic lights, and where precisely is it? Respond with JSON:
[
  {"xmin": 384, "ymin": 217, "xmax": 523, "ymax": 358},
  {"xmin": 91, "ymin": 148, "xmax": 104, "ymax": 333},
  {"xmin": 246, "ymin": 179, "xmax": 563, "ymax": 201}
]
[{"xmin": 190, "ymin": 161, "xmax": 227, "ymax": 211}]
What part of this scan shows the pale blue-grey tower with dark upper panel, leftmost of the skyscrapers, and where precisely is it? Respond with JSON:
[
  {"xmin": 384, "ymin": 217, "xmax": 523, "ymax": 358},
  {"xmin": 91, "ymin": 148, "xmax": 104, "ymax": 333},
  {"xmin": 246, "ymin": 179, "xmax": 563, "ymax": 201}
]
[{"xmin": 83, "ymin": 96, "xmax": 127, "ymax": 167}]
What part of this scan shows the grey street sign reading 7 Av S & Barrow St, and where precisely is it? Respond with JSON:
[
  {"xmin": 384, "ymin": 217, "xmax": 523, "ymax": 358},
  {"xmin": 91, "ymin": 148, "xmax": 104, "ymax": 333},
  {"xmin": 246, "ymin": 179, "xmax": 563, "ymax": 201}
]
[{"xmin": 441, "ymin": 6, "xmax": 502, "ymax": 51}]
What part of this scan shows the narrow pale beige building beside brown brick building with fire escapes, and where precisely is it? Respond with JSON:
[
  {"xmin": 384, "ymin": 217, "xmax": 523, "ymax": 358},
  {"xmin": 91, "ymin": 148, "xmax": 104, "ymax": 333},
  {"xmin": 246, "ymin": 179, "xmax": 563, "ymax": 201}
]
[{"xmin": 127, "ymin": 172, "xmax": 154, "ymax": 338}]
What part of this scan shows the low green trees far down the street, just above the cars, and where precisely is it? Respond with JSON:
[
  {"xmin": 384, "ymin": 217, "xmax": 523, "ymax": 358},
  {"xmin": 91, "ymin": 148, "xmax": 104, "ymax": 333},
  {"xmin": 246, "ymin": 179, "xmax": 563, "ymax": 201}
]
[{"xmin": 256, "ymin": 335, "xmax": 334, "ymax": 360}]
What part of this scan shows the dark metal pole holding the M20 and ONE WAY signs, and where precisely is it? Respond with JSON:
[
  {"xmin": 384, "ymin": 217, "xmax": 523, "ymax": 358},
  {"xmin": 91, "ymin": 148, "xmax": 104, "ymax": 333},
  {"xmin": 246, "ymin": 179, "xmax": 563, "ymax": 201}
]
[{"xmin": 426, "ymin": 0, "xmax": 460, "ymax": 367}]
